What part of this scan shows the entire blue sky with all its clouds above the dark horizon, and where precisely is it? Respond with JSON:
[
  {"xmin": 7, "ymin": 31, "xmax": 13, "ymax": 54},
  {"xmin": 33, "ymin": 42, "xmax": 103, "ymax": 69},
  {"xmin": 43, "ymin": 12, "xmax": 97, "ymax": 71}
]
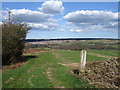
[{"xmin": 2, "ymin": 0, "xmax": 118, "ymax": 39}]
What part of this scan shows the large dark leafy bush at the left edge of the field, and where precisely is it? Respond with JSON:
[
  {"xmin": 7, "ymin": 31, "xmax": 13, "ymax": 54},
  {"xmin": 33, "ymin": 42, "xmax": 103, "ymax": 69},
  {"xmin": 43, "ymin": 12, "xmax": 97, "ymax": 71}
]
[{"xmin": 1, "ymin": 22, "xmax": 31, "ymax": 65}]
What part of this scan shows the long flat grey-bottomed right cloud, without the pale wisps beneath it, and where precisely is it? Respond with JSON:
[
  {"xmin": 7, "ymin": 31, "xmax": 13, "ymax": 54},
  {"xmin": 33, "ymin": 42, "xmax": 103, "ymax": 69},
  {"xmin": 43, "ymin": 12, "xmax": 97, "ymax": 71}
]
[{"xmin": 64, "ymin": 10, "xmax": 118, "ymax": 24}]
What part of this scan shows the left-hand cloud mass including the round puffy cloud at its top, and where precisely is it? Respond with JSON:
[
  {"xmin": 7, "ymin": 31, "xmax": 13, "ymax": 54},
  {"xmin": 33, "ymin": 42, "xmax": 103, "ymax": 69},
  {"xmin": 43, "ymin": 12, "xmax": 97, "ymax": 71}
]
[{"xmin": 3, "ymin": 0, "xmax": 64, "ymax": 31}]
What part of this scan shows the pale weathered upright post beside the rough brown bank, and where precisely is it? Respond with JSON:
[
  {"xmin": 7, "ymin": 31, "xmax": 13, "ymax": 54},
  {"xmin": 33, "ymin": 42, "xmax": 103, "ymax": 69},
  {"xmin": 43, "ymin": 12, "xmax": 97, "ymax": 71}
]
[{"xmin": 80, "ymin": 50, "xmax": 87, "ymax": 72}]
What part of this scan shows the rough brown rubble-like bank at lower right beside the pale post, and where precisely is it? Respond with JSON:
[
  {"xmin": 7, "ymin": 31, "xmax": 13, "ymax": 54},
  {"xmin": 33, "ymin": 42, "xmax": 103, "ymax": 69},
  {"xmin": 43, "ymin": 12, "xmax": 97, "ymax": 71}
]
[{"xmin": 73, "ymin": 58, "xmax": 120, "ymax": 88}]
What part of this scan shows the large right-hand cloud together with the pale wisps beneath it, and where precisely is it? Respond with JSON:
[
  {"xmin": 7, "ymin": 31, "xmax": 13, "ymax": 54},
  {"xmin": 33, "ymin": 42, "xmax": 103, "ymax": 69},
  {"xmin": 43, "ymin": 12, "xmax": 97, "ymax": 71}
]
[{"xmin": 63, "ymin": 10, "xmax": 118, "ymax": 31}]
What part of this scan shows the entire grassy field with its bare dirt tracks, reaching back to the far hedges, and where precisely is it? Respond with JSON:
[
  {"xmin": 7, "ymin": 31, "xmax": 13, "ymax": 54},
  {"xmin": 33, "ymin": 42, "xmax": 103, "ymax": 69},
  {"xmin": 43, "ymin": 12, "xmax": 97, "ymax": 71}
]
[{"xmin": 3, "ymin": 41, "xmax": 118, "ymax": 88}]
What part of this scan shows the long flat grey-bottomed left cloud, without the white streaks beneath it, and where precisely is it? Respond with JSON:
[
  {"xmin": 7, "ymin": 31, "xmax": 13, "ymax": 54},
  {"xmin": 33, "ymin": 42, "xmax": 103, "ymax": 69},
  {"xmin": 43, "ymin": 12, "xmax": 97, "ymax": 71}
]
[{"xmin": 11, "ymin": 9, "xmax": 52, "ymax": 22}]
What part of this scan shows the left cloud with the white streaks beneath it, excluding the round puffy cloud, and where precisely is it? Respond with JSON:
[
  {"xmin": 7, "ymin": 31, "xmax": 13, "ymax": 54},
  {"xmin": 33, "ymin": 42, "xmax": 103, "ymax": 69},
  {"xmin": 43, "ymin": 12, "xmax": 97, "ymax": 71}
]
[{"xmin": 4, "ymin": 9, "xmax": 57, "ymax": 31}]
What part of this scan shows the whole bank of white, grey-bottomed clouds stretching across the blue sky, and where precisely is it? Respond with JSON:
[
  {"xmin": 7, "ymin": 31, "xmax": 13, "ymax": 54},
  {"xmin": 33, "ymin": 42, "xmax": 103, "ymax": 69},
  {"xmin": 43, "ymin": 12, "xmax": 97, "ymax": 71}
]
[{"xmin": 3, "ymin": 0, "xmax": 118, "ymax": 32}]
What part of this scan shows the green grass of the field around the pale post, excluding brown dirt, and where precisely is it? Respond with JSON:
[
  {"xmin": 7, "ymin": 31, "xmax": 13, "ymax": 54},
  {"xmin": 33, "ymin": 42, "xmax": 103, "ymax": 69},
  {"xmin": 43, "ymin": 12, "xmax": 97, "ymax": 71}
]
[{"xmin": 2, "ymin": 50, "xmax": 116, "ymax": 88}]
